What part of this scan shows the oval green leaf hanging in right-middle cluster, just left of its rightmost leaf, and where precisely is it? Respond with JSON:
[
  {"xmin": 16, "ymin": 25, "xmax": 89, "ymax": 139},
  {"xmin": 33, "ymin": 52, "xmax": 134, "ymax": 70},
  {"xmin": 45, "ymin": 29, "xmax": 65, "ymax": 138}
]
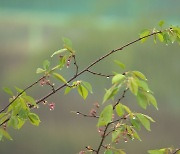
[{"xmin": 136, "ymin": 91, "xmax": 148, "ymax": 109}]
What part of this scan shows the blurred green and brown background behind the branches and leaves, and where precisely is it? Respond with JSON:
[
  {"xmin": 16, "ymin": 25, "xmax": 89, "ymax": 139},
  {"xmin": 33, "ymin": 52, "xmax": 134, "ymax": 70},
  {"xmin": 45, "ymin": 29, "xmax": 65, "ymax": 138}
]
[{"xmin": 0, "ymin": 0, "xmax": 180, "ymax": 154}]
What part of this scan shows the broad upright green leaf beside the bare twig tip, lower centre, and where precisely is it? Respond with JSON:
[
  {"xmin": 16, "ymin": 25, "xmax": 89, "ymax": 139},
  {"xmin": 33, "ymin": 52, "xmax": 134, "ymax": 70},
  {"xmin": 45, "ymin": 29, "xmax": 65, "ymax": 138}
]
[{"xmin": 97, "ymin": 105, "xmax": 113, "ymax": 127}]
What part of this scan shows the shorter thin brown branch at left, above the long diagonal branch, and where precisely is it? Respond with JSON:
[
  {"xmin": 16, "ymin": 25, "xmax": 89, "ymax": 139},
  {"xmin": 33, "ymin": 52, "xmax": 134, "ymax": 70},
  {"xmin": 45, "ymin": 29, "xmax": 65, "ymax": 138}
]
[{"xmin": 0, "ymin": 76, "xmax": 46, "ymax": 113}]
